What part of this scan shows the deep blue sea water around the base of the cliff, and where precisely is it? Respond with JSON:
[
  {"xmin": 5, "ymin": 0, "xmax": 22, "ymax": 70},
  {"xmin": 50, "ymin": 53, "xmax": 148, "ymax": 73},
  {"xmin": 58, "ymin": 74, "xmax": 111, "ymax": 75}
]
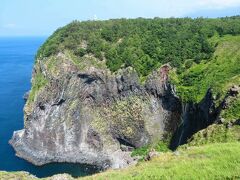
[{"xmin": 0, "ymin": 37, "xmax": 96, "ymax": 177}]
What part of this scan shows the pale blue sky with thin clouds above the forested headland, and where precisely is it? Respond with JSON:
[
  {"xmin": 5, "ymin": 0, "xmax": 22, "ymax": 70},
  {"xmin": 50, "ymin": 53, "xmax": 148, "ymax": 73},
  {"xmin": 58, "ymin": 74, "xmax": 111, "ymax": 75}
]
[{"xmin": 0, "ymin": 0, "xmax": 240, "ymax": 36}]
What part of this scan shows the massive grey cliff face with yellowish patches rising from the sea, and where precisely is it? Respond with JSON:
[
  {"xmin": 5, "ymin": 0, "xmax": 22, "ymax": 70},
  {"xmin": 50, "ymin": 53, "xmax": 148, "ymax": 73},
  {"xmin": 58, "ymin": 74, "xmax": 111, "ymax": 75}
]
[{"xmin": 10, "ymin": 52, "xmax": 181, "ymax": 168}]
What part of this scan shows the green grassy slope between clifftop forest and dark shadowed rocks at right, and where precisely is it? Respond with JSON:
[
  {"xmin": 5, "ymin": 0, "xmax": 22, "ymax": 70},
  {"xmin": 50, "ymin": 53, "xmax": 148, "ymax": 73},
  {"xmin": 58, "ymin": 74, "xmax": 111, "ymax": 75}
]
[{"xmin": 173, "ymin": 35, "xmax": 240, "ymax": 102}]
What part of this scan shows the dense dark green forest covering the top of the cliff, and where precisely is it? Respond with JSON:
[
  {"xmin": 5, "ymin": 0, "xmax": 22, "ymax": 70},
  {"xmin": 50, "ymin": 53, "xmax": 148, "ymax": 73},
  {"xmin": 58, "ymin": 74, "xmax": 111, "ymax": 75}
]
[{"xmin": 37, "ymin": 16, "xmax": 240, "ymax": 77}]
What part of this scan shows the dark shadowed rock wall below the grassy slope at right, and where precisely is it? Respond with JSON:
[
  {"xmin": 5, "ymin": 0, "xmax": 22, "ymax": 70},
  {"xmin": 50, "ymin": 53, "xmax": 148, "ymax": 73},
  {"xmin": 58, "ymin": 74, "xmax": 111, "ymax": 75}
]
[{"xmin": 171, "ymin": 85, "xmax": 240, "ymax": 149}]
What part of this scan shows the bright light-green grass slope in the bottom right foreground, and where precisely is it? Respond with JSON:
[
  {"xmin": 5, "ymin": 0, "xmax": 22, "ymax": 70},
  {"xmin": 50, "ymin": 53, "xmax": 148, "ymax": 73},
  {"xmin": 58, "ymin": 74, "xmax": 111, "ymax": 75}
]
[{"xmin": 83, "ymin": 142, "xmax": 240, "ymax": 180}]
